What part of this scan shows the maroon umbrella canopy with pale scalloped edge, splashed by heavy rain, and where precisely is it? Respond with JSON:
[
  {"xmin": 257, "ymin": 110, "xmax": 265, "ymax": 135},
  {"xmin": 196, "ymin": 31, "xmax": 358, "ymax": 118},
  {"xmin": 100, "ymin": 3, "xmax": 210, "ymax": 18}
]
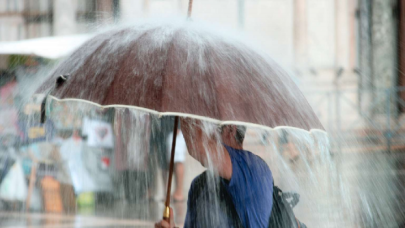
[{"xmin": 38, "ymin": 21, "xmax": 323, "ymax": 130}]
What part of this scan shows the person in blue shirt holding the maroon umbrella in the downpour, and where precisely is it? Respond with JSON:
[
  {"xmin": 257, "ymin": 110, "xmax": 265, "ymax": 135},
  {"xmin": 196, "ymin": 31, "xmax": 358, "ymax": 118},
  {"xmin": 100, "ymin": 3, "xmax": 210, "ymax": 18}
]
[{"xmin": 155, "ymin": 118, "xmax": 273, "ymax": 228}]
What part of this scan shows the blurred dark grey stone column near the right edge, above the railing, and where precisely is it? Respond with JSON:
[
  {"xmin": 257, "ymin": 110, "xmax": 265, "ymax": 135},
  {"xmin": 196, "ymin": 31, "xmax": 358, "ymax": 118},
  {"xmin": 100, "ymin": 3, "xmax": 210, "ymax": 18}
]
[{"xmin": 359, "ymin": 0, "xmax": 398, "ymax": 115}]
